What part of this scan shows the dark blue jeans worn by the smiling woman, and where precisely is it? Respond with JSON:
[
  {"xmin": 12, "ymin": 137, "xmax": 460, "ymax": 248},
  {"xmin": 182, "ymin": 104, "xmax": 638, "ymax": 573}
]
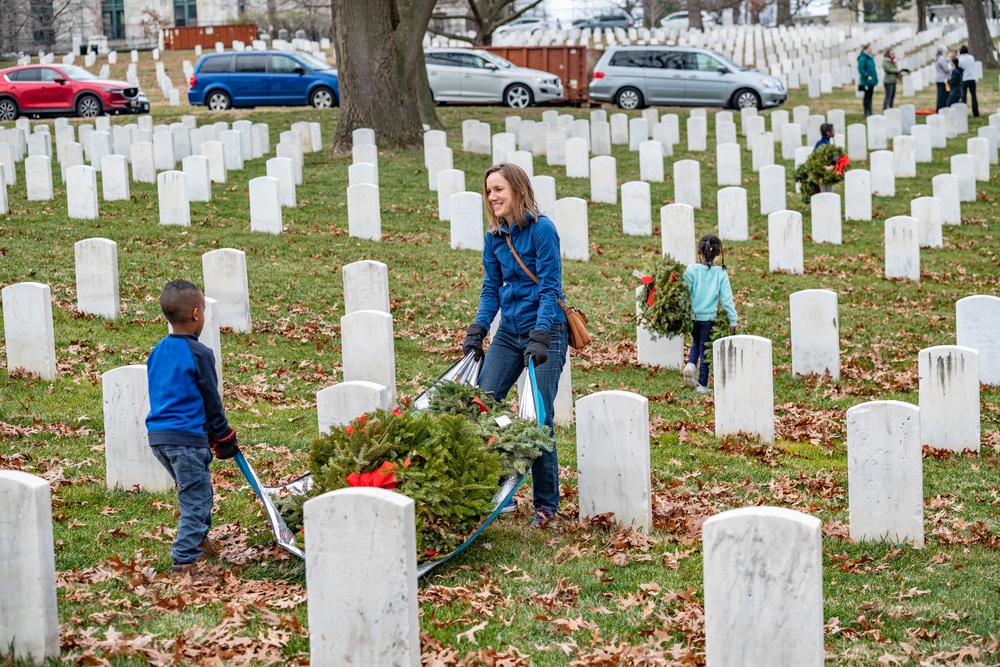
[{"xmin": 479, "ymin": 324, "xmax": 569, "ymax": 512}]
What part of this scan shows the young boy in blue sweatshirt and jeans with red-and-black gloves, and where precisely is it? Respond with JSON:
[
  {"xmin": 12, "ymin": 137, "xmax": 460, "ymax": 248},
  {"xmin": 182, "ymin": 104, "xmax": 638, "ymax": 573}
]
[{"xmin": 146, "ymin": 280, "xmax": 239, "ymax": 573}]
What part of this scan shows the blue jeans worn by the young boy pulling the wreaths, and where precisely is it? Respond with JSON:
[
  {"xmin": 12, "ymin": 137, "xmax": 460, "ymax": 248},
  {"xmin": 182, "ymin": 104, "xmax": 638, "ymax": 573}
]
[{"xmin": 152, "ymin": 445, "xmax": 212, "ymax": 565}]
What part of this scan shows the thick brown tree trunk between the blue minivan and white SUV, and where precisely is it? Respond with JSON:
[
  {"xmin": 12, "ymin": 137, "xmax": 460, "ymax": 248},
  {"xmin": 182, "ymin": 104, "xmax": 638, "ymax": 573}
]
[{"xmin": 333, "ymin": 0, "xmax": 439, "ymax": 154}]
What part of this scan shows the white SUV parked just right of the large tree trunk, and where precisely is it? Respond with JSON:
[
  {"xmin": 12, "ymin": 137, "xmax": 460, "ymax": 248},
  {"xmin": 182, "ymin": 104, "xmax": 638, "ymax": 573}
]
[{"xmin": 424, "ymin": 48, "xmax": 563, "ymax": 109}]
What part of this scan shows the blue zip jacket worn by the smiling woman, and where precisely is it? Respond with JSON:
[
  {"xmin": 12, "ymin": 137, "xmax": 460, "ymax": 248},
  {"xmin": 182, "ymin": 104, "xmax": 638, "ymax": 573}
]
[{"xmin": 476, "ymin": 215, "xmax": 566, "ymax": 334}]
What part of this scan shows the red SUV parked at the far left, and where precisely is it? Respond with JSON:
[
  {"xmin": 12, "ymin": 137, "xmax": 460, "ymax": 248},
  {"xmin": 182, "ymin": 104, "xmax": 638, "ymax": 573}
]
[{"xmin": 0, "ymin": 65, "xmax": 149, "ymax": 121}]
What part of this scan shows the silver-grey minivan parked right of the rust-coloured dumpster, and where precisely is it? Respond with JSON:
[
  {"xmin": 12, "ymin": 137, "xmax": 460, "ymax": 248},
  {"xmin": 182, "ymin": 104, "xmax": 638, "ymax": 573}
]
[{"xmin": 588, "ymin": 46, "xmax": 788, "ymax": 109}]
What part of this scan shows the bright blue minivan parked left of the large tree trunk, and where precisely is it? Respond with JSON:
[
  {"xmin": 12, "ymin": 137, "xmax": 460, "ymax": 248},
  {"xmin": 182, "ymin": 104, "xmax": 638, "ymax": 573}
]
[{"xmin": 188, "ymin": 51, "xmax": 340, "ymax": 111}]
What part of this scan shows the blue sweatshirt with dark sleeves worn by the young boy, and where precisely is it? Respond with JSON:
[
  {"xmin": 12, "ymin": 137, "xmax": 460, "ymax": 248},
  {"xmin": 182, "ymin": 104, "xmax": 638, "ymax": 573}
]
[{"xmin": 146, "ymin": 334, "xmax": 230, "ymax": 447}]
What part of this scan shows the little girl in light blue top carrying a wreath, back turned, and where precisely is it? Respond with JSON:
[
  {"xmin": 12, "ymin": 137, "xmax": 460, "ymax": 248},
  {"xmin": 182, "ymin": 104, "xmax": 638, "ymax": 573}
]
[{"xmin": 684, "ymin": 234, "xmax": 736, "ymax": 394}]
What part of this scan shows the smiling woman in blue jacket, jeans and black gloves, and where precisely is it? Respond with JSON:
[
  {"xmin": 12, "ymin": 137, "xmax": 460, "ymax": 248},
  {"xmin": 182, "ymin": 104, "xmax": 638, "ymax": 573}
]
[{"xmin": 462, "ymin": 163, "xmax": 569, "ymax": 527}]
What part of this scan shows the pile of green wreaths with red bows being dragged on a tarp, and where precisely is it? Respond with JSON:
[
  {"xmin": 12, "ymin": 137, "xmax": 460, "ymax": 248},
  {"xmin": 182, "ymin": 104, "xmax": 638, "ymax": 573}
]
[{"xmin": 275, "ymin": 382, "xmax": 552, "ymax": 560}]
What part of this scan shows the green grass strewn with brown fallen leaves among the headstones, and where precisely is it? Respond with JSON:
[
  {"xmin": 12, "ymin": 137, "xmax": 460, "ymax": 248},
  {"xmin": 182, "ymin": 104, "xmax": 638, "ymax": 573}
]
[{"xmin": 0, "ymin": 48, "xmax": 1000, "ymax": 666}]
